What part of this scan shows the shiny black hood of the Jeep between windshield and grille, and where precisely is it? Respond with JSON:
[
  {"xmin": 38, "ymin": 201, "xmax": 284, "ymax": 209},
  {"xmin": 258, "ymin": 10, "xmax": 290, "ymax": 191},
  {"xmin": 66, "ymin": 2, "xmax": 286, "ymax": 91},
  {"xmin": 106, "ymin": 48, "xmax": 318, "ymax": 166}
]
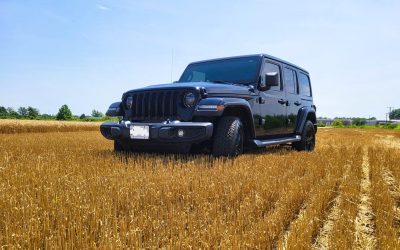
[{"xmin": 127, "ymin": 82, "xmax": 252, "ymax": 96}]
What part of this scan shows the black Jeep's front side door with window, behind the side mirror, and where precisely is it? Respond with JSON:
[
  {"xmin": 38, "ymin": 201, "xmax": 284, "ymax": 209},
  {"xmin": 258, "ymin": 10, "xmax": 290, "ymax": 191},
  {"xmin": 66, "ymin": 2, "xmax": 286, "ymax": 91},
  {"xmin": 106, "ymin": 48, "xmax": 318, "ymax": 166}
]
[{"xmin": 257, "ymin": 59, "xmax": 287, "ymax": 138}]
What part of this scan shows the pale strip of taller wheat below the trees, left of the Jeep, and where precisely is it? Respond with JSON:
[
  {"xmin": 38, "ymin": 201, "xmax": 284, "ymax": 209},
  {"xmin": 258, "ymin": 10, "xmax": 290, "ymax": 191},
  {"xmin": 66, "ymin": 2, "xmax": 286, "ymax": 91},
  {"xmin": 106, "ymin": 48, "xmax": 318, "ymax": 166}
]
[{"xmin": 0, "ymin": 120, "xmax": 100, "ymax": 134}]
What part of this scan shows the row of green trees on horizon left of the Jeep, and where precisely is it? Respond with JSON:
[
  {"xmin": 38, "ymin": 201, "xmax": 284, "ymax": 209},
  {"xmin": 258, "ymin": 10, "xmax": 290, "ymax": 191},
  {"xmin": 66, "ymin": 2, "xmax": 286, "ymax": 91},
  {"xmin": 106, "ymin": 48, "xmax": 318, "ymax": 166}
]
[{"xmin": 0, "ymin": 104, "xmax": 109, "ymax": 121}]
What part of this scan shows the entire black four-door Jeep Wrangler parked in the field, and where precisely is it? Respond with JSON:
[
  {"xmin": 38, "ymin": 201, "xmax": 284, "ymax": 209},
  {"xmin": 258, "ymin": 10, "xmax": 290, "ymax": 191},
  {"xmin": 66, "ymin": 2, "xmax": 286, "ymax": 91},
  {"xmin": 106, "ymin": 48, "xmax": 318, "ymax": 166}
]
[{"xmin": 100, "ymin": 54, "xmax": 317, "ymax": 156}]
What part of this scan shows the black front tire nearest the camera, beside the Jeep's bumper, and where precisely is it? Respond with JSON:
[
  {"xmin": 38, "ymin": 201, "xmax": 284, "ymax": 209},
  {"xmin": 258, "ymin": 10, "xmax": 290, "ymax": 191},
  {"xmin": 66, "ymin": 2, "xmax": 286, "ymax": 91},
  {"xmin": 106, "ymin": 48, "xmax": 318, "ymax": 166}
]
[{"xmin": 212, "ymin": 116, "xmax": 244, "ymax": 156}]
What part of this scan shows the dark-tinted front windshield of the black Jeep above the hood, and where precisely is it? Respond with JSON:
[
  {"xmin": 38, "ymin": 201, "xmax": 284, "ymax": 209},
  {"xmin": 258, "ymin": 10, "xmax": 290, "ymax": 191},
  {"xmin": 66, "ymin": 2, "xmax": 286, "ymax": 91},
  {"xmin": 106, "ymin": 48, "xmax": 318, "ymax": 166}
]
[{"xmin": 179, "ymin": 56, "xmax": 261, "ymax": 84}]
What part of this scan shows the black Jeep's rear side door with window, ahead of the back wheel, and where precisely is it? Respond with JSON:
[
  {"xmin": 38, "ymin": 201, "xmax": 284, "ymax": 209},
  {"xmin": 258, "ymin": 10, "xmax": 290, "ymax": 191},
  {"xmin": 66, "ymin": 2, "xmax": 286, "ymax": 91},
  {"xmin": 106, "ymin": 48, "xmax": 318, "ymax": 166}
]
[{"xmin": 283, "ymin": 65, "xmax": 302, "ymax": 134}]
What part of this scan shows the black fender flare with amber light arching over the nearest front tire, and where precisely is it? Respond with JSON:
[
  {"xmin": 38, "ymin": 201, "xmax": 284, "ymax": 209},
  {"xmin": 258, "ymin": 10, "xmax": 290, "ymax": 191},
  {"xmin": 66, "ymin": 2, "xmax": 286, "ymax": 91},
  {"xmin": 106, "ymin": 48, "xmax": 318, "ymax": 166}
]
[{"xmin": 193, "ymin": 97, "xmax": 255, "ymax": 138}]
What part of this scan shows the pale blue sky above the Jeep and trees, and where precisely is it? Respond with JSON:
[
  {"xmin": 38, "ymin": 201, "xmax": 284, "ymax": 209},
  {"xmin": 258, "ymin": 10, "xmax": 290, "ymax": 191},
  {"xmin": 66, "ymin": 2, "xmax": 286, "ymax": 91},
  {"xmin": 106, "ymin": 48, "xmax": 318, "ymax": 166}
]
[{"xmin": 0, "ymin": 0, "xmax": 400, "ymax": 119}]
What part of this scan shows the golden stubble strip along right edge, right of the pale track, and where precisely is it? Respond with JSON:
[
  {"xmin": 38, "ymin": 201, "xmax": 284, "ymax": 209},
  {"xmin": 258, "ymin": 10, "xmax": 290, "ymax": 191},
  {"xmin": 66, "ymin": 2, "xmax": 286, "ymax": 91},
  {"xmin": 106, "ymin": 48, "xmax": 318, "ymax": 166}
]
[{"xmin": 369, "ymin": 148, "xmax": 400, "ymax": 249}]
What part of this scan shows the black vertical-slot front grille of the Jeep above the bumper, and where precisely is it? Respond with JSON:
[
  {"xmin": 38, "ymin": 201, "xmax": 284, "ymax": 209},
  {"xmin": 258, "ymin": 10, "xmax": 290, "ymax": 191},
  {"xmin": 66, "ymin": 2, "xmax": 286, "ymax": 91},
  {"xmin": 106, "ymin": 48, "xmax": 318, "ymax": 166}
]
[{"xmin": 124, "ymin": 90, "xmax": 184, "ymax": 121}]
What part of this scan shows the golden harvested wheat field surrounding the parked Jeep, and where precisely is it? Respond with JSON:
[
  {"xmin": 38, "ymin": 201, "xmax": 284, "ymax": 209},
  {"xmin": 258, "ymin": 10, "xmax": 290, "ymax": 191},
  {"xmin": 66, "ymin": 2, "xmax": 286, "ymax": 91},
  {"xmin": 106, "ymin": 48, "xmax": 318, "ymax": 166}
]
[{"xmin": 0, "ymin": 122, "xmax": 400, "ymax": 249}]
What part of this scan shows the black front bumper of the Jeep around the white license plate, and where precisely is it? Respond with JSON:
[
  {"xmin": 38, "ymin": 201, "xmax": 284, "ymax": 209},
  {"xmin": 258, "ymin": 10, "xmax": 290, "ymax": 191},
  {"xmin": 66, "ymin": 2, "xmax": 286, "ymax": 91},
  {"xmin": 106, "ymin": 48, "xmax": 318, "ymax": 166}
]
[{"xmin": 100, "ymin": 121, "xmax": 213, "ymax": 143}]
